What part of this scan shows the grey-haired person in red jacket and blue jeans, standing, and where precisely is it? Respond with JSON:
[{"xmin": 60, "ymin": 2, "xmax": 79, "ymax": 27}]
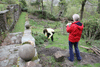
[{"xmin": 66, "ymin": 14, "xmax": 83, "ymax": 61}]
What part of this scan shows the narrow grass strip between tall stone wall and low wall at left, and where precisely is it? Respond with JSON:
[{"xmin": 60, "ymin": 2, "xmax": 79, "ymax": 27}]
[{"xmin": 12, "ymin": 12, "xmax": 27, "ymax": 33}]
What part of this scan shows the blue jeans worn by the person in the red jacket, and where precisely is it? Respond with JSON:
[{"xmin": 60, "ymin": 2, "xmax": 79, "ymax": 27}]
[{"xmin": 68, "ymin": 41, "xmax": 82, "ymax": 61}]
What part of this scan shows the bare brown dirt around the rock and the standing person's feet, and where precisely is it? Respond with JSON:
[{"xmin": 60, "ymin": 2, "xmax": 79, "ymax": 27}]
[{"xmin": 37, "ymin": 43, "xmax": 100, "ymax": 67}]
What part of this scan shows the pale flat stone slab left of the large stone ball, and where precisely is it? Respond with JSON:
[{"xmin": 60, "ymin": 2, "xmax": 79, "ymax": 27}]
[{"xmin": 0, "ymin": 44, "xmax": 20, "ymax": 67}]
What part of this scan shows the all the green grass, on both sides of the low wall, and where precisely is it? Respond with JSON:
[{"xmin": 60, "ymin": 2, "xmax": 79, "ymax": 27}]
[{"xmin": 13, "ymin": 12, "xmax": 100, "ymax": 67}]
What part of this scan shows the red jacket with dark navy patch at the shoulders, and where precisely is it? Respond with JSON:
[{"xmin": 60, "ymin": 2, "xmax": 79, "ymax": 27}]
[{"xmin": 66, "ymin": 21, "xmax": 83, "ymax": 42}]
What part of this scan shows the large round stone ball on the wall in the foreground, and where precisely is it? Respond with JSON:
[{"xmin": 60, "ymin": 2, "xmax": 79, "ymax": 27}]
[{"xmin": 19, "ymin": 44, "xmax": 35, "ymax": 61}]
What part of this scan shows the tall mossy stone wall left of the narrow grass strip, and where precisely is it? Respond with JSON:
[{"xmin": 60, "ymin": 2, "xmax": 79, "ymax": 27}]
[{"xmin": 0, "ymin": 4, "xmax": 21, "ymax": 35}]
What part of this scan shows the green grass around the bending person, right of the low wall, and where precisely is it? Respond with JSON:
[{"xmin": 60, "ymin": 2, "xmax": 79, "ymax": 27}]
[{"xmin": 29, "ymin": 19, "xmax": 100, "ymax": 53}]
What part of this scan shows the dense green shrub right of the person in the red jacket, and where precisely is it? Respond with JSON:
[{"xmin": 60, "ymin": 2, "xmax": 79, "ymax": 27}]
[{"xmin": 82, "ymin": 17, "xmax": 100, "ymax": 40}]
